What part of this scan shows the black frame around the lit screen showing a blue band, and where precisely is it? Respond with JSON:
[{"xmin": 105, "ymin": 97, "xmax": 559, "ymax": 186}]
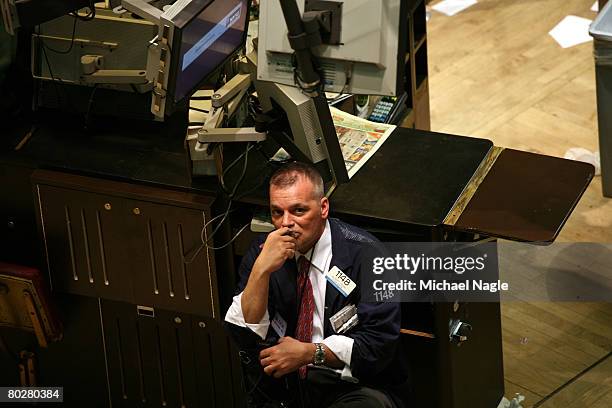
[{"xmin": 165, "ymin": 0, "xmax": 251, "ymax": 115}]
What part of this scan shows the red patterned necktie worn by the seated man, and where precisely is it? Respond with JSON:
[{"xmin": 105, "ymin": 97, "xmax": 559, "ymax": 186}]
[{"xmin": 295, "ymin": 256, "xmax": 314, "ymax": 379}]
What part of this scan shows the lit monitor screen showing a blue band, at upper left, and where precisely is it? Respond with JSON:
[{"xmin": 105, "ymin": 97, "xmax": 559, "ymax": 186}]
[{"xmin": 173, "ymin": 0, "xmax": 249, "ymax": 103}]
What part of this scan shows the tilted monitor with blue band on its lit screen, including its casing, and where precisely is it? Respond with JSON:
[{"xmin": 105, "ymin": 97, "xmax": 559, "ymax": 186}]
[{"xmin": 152, "ymin": 0, "xmax": 250, "ymax": 115}]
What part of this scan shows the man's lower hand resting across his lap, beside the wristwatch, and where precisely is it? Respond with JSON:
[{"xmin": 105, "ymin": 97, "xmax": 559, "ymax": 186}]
[{"xmin": 259, "ymin": 337, "xmax": 315, "ymax": 378}]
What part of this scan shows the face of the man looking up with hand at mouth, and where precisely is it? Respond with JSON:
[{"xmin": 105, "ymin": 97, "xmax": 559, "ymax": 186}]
[{"xmin": 270, "ymin": 176, "xmax": 329, "ymax": 253}]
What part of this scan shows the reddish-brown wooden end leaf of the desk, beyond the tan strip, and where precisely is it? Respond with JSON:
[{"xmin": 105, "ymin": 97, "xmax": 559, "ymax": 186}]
[{"xmin": 454, "ymin": 149, "xmax": 594, "ymax": 243}]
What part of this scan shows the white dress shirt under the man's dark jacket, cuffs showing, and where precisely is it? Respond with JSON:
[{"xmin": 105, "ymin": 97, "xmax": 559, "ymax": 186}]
[{"xmin": 225, "ymin": 221, "xmax": 357, "ymax": 381}]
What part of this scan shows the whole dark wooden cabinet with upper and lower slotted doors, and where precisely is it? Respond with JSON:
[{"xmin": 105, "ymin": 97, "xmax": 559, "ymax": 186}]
[{"xmin": 18, "ymin": 170, "xmax": 245, "ymax": 407}]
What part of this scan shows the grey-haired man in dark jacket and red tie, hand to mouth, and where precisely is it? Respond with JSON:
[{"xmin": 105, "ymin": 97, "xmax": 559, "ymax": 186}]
[{"xmin": 225, "ymin": 162, "xmax": 406, "ymax": 407}]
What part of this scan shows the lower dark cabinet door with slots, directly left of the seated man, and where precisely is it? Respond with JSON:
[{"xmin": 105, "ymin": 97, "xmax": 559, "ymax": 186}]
[{"xmin": 100, "ymin": 300, "xmax": 244, "ymax": 407}]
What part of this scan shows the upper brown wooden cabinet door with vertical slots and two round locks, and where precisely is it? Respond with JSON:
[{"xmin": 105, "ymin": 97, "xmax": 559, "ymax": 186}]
[{"xmin": 33, "ymin": 171, "xmax": 220, "ymax": 318}]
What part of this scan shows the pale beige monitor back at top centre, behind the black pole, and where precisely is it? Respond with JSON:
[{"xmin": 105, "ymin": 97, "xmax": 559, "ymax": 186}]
[{"xmin": 257, "ymin": 0, "xmax": 408, "ymax": 96}]
